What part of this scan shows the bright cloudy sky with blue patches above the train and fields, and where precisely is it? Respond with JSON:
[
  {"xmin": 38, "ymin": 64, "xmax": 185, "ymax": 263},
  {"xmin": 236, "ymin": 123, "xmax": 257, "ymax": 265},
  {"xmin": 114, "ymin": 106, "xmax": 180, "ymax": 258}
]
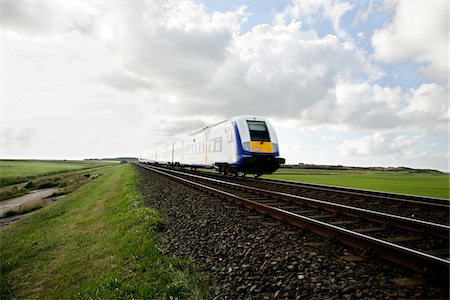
[{"xmin": 0, "ymin": 0, "xmax": 450, "ymax": 171}]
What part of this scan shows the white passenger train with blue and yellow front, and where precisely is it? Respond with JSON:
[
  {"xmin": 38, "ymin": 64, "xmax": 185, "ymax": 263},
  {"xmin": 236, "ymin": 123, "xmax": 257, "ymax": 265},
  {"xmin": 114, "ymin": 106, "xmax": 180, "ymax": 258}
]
[{"xmin": 139, "ymin": 116, "xmax": 285, "ymax": 175}]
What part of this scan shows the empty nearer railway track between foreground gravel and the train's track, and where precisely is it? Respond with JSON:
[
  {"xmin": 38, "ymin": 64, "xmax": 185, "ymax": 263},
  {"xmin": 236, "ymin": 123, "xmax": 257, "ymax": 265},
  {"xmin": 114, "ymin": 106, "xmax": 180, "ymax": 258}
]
[{"xmin": 135, "ymin": 165, "xmax": 450, "ymax": 286}]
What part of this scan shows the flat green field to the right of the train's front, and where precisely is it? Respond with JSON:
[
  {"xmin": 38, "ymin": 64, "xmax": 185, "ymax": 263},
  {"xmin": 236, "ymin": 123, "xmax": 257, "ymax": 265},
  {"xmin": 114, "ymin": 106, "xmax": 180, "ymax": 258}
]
[{"xmin": 263, "ymin": 169, "xmax": 450, "ymax": 199}]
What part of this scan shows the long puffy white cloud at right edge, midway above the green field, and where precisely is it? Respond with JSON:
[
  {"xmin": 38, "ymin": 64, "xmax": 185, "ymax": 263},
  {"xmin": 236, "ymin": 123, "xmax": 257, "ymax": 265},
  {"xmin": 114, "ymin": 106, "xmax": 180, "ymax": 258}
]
[{"xmin": 302, "ymin": 82, "xmax": 450, "ymax": 131}]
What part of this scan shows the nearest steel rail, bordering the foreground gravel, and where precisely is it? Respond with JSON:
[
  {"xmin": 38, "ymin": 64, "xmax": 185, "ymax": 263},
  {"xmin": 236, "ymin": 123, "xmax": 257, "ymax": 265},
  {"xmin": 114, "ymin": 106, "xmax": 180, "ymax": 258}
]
[{"xmin": 139, "ymin": 165, "xmax": 450, "ymax": 286}]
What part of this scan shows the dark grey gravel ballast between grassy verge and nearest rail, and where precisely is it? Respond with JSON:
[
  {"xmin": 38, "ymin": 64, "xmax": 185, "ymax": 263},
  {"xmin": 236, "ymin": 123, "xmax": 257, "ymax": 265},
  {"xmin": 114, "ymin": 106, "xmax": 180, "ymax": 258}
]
[{"xmin": 137, "ymin": 167, "xmax": 448, "ymax": 299}]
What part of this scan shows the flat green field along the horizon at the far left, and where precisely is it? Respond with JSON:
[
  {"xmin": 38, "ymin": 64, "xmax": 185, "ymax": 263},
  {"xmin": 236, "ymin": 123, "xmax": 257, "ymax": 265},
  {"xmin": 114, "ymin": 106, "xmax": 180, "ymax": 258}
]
[{"xmin": 0, "ymin": 160, "xmax": 112, "ymax": 186}]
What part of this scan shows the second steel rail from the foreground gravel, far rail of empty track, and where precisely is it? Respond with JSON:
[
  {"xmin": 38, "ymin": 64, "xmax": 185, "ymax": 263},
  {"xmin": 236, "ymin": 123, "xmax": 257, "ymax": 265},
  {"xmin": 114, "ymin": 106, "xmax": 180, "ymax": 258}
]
[{"xmin": 144, "ymin": 167, "xmax": 450, "ymax": 239}]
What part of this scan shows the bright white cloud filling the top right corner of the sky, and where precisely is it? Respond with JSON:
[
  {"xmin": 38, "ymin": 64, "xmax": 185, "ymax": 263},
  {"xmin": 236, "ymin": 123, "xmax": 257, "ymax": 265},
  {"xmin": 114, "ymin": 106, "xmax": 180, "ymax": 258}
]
[{"xmin": 372, "ymin": 0, "xmax": 449, "ymax": 82}]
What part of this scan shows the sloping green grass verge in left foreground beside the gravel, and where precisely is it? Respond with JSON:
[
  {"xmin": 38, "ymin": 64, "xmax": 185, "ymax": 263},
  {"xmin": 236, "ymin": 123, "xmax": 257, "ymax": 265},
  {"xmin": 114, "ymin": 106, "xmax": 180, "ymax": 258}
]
[{"xmin": 0, "ymin": 164, "xmax": 203, "ymax": 299}]
